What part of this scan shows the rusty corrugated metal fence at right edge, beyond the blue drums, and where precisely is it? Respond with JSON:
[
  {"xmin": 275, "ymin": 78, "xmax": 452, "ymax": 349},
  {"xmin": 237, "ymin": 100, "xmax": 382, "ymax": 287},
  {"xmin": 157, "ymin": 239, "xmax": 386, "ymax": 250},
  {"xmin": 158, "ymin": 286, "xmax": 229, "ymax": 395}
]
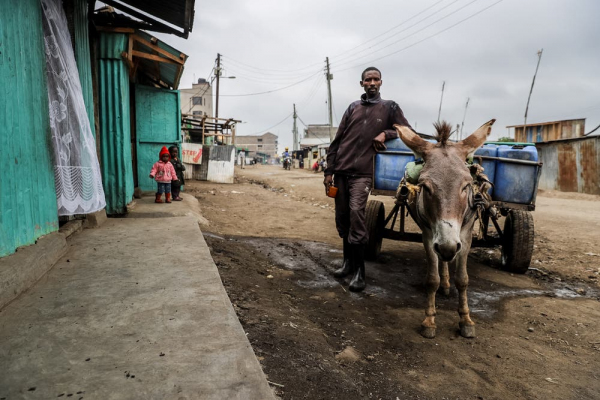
[{"xmin": 536, "ymin": 136, "xmax": 600, "ymax": 194}]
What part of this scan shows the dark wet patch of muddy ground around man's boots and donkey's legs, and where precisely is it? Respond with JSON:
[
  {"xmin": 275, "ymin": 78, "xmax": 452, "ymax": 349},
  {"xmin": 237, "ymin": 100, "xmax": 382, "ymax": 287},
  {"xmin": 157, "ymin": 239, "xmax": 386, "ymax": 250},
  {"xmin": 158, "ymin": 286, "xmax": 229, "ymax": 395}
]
[{"xmin": 211, "ymin": 233, "xmax": 600, "ymax": 318}]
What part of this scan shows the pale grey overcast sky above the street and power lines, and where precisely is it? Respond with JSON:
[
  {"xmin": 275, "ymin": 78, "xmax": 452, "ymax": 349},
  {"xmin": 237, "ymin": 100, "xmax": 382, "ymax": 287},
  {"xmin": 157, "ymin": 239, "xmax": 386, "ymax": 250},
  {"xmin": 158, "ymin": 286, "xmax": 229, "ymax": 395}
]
[{"xmin": 159, "ymin": 0, "xmax": 600, "ymax": 152}]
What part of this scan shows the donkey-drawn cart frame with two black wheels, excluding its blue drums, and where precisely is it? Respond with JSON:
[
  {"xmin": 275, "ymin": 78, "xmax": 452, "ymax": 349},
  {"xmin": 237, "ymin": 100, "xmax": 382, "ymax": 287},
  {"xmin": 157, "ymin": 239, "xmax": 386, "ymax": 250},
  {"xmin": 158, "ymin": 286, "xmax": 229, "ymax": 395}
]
[{"xmin": 365, "ymin": 150, "xmax": 542, "ymax": 274}]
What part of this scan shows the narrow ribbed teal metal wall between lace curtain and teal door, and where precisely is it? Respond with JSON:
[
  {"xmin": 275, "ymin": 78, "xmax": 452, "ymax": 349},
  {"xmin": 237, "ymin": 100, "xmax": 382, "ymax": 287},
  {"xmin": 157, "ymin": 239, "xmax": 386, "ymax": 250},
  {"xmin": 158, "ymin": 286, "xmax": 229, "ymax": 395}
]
[{"xmin": 98, "ymin": 33, "xmax": 134, "ymax": 214}]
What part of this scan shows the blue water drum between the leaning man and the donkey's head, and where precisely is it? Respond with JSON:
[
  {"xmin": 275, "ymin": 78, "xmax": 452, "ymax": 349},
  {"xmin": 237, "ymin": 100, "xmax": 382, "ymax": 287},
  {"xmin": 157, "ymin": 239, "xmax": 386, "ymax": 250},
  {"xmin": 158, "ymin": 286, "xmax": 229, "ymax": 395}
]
[{"xmin": 374, "ymin": 139, "xmax": 415, "ymax": 191}]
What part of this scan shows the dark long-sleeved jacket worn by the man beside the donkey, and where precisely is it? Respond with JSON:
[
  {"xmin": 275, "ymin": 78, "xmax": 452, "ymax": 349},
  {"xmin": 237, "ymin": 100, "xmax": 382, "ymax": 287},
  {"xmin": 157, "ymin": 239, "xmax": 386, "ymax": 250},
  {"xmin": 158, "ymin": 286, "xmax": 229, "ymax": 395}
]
[{"xmin": 325, "ymin": 94, "xmax": 410, "ymax": 176}]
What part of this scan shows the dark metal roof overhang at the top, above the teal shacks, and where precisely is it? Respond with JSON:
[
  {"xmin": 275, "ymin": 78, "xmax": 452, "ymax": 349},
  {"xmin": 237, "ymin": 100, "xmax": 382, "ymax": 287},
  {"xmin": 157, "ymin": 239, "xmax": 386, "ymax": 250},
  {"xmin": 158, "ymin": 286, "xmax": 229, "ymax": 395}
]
[{"xmin": 97, "ymin": 0, "xmax": 195, "ymax": 38}]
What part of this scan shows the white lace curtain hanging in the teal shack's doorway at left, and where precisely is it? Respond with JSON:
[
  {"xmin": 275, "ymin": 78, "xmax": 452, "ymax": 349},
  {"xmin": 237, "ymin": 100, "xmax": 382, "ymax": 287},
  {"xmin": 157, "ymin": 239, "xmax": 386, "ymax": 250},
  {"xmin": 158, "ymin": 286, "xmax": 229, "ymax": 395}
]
[{"xmin": 41, "ymin": 0, "xmax": 106, "ymax": 215}]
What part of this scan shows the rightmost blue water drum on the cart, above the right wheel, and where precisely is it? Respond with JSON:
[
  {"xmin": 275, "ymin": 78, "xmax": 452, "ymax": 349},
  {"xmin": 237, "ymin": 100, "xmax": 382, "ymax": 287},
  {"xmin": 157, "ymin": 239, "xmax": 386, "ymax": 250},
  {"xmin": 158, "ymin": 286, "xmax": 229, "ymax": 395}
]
[{"xmin": 492, "ymin": 145, "xmax": 539, "ymax": 204}]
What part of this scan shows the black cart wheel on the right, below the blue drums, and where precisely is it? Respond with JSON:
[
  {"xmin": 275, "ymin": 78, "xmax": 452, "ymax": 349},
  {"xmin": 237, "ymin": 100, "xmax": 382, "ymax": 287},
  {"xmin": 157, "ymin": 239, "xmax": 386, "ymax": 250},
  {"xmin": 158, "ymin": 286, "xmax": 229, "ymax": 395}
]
[{"xmin": 502, "ymin": 210, "xmax": 534, "ymax": 274}]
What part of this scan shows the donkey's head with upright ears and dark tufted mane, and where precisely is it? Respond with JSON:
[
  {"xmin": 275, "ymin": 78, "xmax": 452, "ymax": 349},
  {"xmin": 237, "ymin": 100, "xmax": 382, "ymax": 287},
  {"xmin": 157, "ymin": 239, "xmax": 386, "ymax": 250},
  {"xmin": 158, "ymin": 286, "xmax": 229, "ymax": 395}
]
[{"xmin": 394, "ymin": 119, "xmax": 495, "ymax": 261}]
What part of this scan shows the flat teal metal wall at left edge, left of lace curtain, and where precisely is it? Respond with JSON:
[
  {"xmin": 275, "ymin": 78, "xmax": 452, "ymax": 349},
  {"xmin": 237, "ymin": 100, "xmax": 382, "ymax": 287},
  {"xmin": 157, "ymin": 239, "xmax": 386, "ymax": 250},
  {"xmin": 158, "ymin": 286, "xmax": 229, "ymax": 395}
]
[{"xmin": 0, "ymin": 0, "xmax": 58, "ymax": 256}]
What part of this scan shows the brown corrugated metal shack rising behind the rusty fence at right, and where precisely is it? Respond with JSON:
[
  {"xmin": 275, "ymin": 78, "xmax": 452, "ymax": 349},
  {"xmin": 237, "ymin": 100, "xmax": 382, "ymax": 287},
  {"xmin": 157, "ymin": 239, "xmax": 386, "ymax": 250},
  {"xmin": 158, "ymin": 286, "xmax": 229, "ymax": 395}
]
[{"xmin": 507, "ymin": 118, "xmax": 585, "ymax": 143}]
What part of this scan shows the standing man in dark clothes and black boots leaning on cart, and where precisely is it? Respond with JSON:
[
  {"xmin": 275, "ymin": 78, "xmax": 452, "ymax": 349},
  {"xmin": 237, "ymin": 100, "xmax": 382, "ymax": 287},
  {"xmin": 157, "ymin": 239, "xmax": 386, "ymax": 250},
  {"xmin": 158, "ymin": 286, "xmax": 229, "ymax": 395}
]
[{"xmin": 323, "ymin": 67, "xmax": 410, "ymax": 292}]
